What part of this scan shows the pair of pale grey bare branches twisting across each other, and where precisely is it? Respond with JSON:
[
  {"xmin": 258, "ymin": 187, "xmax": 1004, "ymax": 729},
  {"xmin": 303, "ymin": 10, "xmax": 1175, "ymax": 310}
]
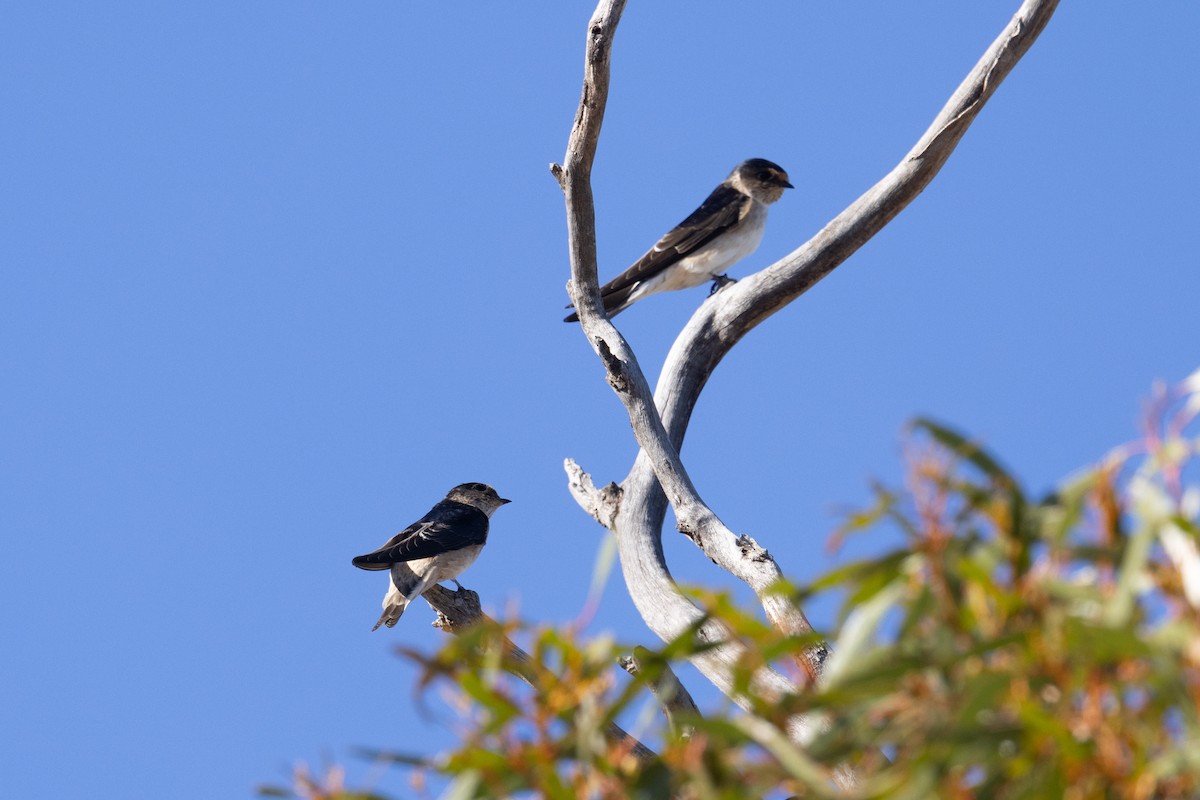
[{"xmin": 554, "ymin": 0, "xmax": 1057, "ymax": 783}]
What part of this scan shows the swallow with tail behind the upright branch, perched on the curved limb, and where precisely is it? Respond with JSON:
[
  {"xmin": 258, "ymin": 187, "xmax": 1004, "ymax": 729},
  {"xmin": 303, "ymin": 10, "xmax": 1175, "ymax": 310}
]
[{"xmin": 563, "ymin": 158, "xmax": 794, "ymax": 323}]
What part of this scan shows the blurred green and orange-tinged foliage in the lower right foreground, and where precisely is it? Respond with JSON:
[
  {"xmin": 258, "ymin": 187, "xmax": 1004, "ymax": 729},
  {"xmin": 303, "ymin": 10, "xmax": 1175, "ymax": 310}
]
[{"xmin": 264, "ymin": 373, "xmax": 1200, "ymax": 800}]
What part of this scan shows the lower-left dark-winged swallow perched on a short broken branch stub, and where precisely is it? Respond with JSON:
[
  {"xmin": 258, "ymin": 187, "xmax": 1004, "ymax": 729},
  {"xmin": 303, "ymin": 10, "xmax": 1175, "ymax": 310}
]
[{"xmin": 350, "ymin": 483, "xmax": 510, "ymax": 631}]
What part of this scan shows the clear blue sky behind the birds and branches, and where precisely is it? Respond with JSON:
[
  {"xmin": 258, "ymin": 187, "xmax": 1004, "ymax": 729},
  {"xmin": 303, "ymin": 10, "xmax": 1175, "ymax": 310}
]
[{"xmin": 0, "ymin": 0, "xmax": 1200, "ymax": 799}]
